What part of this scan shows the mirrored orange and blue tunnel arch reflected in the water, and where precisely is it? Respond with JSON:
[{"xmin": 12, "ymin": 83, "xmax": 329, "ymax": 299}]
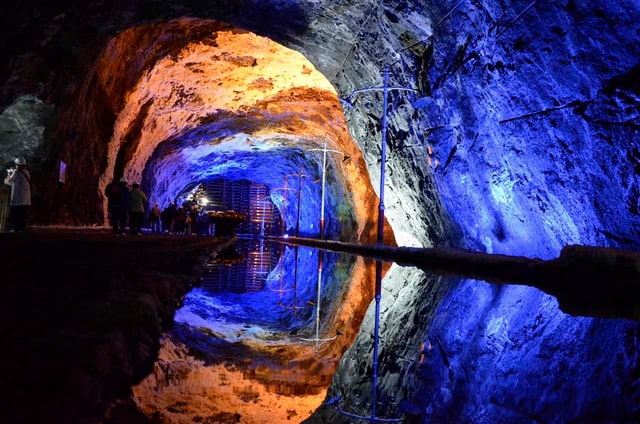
[{"xmin": 134, "ymin": 239, "xmax": 373, "ymax": 424}]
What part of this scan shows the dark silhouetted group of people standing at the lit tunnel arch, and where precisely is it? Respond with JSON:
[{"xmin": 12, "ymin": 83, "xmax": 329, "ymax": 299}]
[{"xmin": 105, "ymin": 177, "xmax": 214, "ymax": 237}]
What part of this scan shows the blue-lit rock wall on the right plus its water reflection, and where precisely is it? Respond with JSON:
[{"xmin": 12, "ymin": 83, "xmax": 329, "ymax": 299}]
[{"xmin": 308, "ymin": 2, "xmax": 640, "ymax": 422}]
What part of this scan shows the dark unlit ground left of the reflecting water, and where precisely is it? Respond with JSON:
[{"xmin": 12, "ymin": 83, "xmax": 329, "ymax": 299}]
[{"xmin": 0, "ymin": 229, "xmax": 228, "ymax": 422}]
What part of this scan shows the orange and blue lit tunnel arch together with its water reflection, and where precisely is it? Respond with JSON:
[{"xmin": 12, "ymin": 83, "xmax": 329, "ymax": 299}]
[{"xmin": 87, "ymin": 19, "xmax": 393, "ymax": 422}]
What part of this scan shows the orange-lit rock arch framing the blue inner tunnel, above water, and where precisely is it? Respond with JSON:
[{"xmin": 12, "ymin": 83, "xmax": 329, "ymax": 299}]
[{"xmin": 63, "ymin": 18, "xmax": 384, "ymax": 245}]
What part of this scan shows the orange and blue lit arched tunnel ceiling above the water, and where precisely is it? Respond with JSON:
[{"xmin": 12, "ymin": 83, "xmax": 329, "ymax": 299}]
[{"xmin": 95, "ymin": 19, "xmax": 384, "ymax": 242}]
